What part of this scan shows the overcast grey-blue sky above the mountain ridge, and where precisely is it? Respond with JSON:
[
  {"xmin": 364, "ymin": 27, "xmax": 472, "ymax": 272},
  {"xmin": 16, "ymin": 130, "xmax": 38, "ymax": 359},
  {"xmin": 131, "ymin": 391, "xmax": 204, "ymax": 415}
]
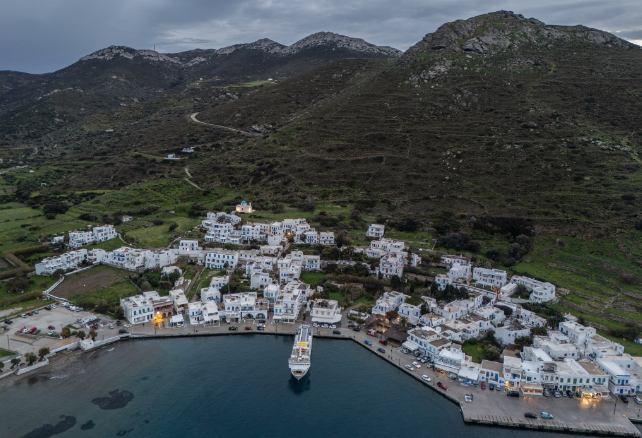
[{"xmin": 0, "ymin": 0, "xmax": 642, "ymax": 73}]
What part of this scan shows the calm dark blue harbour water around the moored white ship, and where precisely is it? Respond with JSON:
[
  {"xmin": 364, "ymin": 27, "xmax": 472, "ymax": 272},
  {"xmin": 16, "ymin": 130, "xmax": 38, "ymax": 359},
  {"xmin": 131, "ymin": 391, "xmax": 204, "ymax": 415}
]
[{"xmin": 0, "ymin": 335, "xmax": 596, "ymax": 438}]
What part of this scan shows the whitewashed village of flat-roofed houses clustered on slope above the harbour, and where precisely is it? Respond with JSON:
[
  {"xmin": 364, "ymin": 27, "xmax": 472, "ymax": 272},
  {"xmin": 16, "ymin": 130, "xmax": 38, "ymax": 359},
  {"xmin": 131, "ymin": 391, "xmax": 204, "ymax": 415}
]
[{"xmin": 27, "ymin": 201, "xmax": 642, "ymax": 398}]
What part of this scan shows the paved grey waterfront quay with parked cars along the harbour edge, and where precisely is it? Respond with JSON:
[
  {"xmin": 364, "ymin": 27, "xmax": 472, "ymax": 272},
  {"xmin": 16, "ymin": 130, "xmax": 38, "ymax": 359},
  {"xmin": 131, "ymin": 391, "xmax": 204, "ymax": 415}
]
[{"xmin": 8, "ymin": 315, "xmax": 641, "ymax": 436}]
